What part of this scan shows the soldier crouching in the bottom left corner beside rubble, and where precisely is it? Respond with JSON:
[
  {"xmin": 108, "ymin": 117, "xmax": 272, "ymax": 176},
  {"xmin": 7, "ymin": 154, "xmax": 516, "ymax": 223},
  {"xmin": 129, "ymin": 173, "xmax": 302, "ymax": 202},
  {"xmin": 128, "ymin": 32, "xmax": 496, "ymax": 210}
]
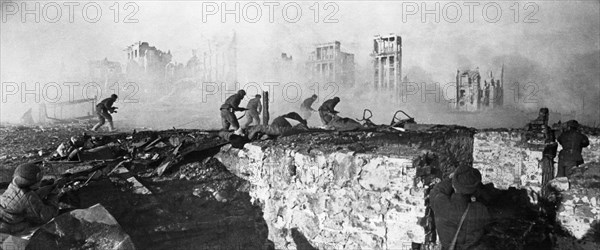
[{"xmin": 0, "ymin": 163, "xmax": 58, "ymax": 234}]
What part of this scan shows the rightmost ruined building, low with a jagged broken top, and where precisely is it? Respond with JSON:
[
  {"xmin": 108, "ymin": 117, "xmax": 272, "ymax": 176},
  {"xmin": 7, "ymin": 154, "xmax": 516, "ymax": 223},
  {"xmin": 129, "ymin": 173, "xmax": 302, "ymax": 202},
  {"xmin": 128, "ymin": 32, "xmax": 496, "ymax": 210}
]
[{"xmin": 455, "ymin": 66, "xmax": 504, "ymax": 111}]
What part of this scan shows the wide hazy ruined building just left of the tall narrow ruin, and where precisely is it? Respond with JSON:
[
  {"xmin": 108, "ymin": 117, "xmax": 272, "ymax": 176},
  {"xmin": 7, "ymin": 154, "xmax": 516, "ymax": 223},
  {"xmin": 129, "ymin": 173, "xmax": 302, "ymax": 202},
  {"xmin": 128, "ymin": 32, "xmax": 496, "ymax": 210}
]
[{"xmin": 306, "ymin": 41, "xmax": 354, "ymax": 86}]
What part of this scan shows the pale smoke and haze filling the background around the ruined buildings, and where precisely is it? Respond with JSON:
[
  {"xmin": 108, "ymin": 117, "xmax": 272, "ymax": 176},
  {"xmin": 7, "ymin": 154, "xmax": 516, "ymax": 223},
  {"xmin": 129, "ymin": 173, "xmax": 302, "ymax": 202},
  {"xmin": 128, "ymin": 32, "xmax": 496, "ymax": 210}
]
[{"xmin": 0, "ymin": 1, "xmax": 600, "ymax": 129}]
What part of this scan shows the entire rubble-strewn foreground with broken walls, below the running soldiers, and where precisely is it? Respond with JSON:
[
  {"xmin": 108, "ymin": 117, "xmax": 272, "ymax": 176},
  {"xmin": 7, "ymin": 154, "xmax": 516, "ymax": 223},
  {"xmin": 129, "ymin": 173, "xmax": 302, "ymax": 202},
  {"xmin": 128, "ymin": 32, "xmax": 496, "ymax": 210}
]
[{"xmin": 0, "ymin": 117, "xmax": 600, "ymax": 249}]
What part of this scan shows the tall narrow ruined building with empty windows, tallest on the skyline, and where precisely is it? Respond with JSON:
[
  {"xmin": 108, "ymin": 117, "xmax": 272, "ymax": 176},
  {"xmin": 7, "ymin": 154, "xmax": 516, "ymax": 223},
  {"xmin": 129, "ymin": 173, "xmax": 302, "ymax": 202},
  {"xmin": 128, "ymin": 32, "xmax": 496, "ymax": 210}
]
[{"xmin": 371, "ymin": 34, "xmax": 402, "ymax": 91}]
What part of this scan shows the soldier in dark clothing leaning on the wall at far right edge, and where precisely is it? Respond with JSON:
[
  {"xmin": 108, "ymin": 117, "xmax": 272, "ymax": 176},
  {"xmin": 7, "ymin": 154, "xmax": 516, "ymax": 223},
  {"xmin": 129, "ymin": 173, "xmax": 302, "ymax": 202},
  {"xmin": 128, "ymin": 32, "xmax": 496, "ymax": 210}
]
[{"xmin": 556, "ymin": 120, "xmax": 590, "ymax": 177}]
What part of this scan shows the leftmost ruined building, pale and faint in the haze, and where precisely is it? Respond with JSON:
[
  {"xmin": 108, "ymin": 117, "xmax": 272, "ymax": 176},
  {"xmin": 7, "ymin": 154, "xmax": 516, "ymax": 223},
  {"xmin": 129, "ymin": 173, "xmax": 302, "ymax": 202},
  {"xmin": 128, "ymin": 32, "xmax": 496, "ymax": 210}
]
[{"xmin": 125, "ymin": 42, "xmax": 172, "ymax": 76}]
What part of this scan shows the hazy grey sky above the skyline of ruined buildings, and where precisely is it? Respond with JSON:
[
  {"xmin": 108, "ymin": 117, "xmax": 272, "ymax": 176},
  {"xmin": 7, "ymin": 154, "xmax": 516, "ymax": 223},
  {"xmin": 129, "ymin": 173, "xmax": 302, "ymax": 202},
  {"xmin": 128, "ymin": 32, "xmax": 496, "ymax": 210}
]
[{"xmin": 0, "ymin": 1, "xmax": 600, "ymax": 125}]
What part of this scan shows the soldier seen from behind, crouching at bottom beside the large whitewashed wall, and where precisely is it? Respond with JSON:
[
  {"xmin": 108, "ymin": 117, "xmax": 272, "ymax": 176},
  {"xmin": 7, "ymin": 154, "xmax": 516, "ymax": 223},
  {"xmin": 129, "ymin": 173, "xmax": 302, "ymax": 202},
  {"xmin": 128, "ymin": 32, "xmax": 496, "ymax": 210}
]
[{"xmin": 430, "ymin": 167, "xmax": 490, "ymax": 250}]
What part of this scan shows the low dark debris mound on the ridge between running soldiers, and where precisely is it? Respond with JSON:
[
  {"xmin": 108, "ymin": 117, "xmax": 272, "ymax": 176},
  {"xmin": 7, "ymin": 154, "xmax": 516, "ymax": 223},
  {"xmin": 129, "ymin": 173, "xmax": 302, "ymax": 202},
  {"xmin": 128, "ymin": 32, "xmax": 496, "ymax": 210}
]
[{"xmin": 248, "ymin": 112, "xmax": 308, "ymax": 140}]
